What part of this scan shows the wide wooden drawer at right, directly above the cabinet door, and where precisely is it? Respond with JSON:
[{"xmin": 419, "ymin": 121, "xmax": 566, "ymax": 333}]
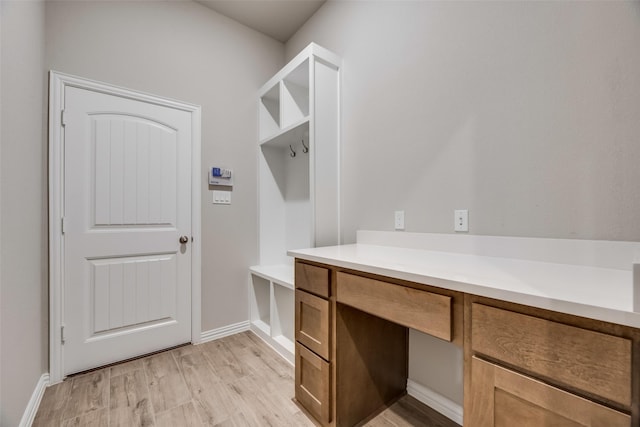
[{"xmin": 471, "ymin": 303, "xmax": 631, "ymax": 407}]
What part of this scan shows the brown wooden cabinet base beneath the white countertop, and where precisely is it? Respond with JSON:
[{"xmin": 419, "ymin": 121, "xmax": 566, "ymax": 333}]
[{"xmin": 295, "ymin": 260, "xmax": 640, "ymax": 427}]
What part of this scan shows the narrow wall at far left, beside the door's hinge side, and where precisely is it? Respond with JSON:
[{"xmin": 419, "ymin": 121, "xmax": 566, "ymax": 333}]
[{"xmin": 0, "ymin": 0, "xmax": 48, "ymax": 426}]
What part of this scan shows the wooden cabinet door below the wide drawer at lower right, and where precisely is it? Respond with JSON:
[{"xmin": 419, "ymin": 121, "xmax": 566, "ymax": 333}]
[{"xmin": 465, "ymin": 357, "xmax": 631, "ymax": 427}]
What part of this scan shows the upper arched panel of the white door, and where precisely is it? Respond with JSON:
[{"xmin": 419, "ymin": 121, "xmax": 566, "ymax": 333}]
[{"xmin": 90, "ymin": 114, "xmax": 178, "ymax": 225}]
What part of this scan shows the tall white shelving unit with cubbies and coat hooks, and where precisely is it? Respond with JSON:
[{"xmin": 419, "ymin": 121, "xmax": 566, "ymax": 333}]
[{"xmin": 249, "ymin": 43, "xmax": 341, "ymax": 363}]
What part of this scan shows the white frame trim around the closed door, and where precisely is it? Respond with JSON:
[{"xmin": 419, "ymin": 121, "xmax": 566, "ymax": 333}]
[{"xmin": 49, "ymin": 70, "xmax": 202, "ymax": 384}]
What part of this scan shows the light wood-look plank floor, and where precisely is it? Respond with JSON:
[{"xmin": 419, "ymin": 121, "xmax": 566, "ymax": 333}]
[{"xmin": 33, "ymin": 332, "xmax": 457, "ymax": 427}]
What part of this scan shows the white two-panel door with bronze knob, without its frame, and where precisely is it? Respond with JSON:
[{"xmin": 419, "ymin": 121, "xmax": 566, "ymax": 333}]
[{"xmin": 62, "ymin": 86, "xmax": 192, "ymax": 375}]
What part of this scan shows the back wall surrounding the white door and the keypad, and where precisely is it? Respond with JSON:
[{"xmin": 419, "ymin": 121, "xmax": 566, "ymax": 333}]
[{"xmin": 46, "ymin": 1, "xmax": 284, "ymax": 331}]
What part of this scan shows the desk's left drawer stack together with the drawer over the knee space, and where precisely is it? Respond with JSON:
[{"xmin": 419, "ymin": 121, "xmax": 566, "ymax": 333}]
[{"xmin": 295, "ymin": 261, "xmax": 462, "ymax": 427}]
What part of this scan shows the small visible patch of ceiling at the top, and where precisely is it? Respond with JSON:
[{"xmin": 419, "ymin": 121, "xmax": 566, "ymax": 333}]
[{"xmin": 196, "ymin": 0, "xmax": 326, "ymax": 43}]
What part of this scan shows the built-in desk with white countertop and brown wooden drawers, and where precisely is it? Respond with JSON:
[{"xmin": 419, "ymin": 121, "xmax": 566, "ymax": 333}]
[{"xmin": 289, "ymin": 234, "xmax": 640, "ymax": 427}]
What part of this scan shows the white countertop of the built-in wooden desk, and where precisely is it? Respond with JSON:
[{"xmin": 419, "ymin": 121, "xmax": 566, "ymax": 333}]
[{"xmin": 288, "ymin": 243, "xmax": 640, "ymax": 328}]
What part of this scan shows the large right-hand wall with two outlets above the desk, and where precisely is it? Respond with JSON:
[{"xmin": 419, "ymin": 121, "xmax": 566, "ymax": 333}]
[{"xmin": 286, "ymin": 0, "xmax": 640, "ymax": 412}]
